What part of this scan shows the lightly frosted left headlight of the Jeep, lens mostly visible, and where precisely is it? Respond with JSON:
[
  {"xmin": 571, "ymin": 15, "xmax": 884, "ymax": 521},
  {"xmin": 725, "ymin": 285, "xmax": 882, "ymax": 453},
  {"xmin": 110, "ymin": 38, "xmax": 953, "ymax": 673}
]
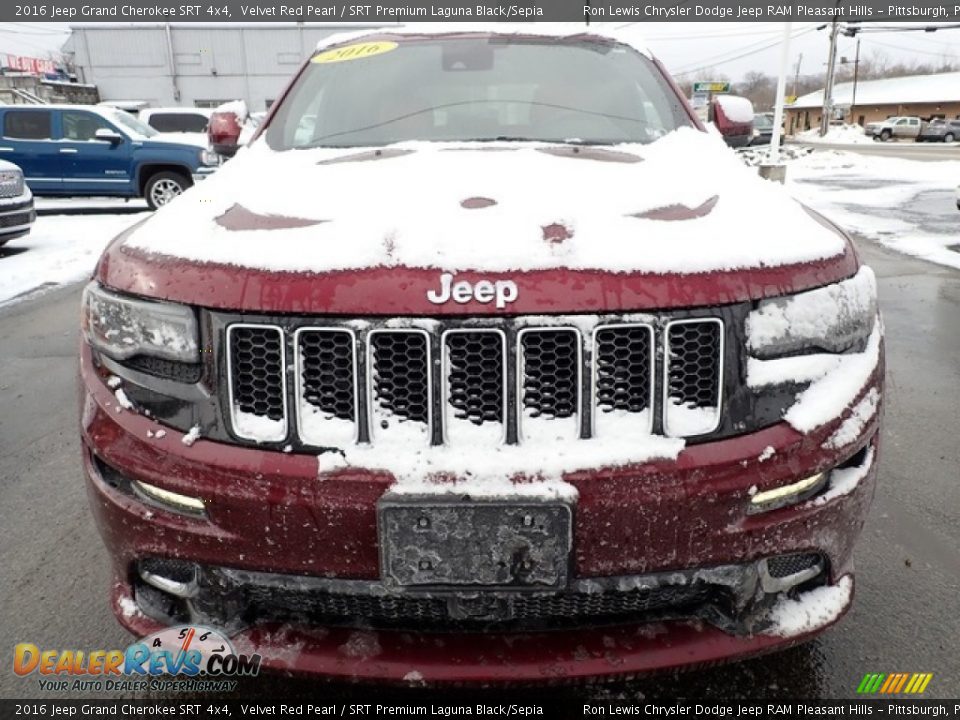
[{"xmin": 80, "ymin": 282, "xmax": 200, "ymax": 363}]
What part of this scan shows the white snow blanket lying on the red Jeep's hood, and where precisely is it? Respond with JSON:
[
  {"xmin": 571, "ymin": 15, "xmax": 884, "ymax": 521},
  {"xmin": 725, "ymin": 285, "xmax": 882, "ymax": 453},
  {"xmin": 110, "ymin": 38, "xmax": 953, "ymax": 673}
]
[{"xmin": 126, "ymin": 128, "xmax": 845, "ymax": 273}]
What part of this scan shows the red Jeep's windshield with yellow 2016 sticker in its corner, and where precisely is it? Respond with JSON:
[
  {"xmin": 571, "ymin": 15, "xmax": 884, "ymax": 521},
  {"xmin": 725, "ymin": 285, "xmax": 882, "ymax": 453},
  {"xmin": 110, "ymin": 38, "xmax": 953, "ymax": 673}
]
[{"xmin": 266, "ymin": 35, "xmax": 691, "ymax": 150}]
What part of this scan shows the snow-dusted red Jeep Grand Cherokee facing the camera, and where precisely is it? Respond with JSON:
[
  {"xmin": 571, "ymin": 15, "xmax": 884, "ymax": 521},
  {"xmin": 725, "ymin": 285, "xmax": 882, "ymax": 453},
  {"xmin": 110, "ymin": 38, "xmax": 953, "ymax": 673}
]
[{"xmin": 80, "ymin": 25, "xmax": 883, "ymax": 683}]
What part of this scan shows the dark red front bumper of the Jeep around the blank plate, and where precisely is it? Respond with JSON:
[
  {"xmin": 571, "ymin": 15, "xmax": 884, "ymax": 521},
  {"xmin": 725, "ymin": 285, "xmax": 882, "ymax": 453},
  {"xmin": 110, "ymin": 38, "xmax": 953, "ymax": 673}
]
[{"xmin": 81, "ymin": 346, "xmax": 883, "ymax": 683}]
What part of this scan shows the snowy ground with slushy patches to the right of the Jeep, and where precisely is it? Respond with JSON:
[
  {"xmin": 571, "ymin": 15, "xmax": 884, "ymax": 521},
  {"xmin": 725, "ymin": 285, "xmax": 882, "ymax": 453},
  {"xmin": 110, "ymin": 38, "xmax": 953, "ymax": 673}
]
[{"xmin": 787, "ymin": 150, "xmax": 960, "ymax": 269}]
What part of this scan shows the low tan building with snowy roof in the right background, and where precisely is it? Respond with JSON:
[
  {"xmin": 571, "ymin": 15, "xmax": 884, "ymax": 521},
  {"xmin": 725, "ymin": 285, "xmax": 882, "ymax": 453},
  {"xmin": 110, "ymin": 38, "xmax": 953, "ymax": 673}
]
[{"xmin": 784, "ymin": 72, "xmax": 960, "ymax": 135}]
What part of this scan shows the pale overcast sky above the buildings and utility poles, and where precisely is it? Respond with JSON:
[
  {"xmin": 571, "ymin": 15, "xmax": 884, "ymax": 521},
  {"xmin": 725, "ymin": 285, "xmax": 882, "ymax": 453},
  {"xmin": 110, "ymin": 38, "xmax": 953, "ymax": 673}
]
[{"xmin": 0, "ymin": 22, "xmax": 960, "ymax": 85}]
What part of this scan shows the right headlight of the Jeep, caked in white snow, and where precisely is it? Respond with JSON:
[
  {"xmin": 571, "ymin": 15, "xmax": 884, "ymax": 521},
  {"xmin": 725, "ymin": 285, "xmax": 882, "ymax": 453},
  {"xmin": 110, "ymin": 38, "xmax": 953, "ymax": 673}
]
[{"xmin": 747, "ymin": 267, "xmax": 877, "ymax": 360}]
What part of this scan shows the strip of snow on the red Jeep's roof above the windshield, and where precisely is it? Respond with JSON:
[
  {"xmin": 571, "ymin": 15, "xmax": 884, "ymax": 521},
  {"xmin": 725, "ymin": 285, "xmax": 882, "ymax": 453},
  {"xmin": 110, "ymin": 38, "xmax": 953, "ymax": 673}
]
[{"xmin": 317, "ymin": 22, "xmax": 650, "ymax": 56}]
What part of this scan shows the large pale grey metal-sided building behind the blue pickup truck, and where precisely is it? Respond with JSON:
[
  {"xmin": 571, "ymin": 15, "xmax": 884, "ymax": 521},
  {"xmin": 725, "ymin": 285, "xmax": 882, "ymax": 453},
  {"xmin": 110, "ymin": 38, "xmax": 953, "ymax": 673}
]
[{"xmin": 63, "ymin": 23, "xmax": 386, "ymax": 111}]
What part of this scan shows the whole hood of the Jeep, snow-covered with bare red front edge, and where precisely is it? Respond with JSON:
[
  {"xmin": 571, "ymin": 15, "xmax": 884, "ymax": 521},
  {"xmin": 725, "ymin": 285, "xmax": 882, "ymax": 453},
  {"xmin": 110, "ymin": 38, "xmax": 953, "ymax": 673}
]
[{"xmin": 100, "ymin": 129, "xmax": 856, "ymax": 314}]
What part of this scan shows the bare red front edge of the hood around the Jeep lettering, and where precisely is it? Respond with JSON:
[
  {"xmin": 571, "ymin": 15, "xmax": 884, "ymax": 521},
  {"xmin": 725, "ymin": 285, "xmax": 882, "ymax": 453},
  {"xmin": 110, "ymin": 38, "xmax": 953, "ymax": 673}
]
[{"xmin": 97, "ymin": 242, "xmax": 858, "ymax": 316}]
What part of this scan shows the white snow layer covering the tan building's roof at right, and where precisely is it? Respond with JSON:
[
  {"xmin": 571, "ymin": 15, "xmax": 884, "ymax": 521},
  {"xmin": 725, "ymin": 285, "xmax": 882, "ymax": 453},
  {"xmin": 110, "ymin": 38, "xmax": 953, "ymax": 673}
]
[{"xmin": 789, "ymin": 72, "xmax": 960, "ymax": 108}]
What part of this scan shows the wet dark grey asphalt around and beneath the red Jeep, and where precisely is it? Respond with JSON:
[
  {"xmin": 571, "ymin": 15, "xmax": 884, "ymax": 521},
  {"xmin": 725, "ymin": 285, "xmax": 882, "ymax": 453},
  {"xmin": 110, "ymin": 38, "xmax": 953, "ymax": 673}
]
[{"xmin": 0, "ymin": 243, "xmax": 960, "ymax": 707}]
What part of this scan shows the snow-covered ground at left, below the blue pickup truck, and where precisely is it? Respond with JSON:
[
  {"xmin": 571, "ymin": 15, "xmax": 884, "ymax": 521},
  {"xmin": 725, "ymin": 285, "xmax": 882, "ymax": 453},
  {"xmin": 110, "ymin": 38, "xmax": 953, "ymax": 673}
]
[{"xmin": 0, "ymin": 198, "xmax": 146, "ymax": 305}]
